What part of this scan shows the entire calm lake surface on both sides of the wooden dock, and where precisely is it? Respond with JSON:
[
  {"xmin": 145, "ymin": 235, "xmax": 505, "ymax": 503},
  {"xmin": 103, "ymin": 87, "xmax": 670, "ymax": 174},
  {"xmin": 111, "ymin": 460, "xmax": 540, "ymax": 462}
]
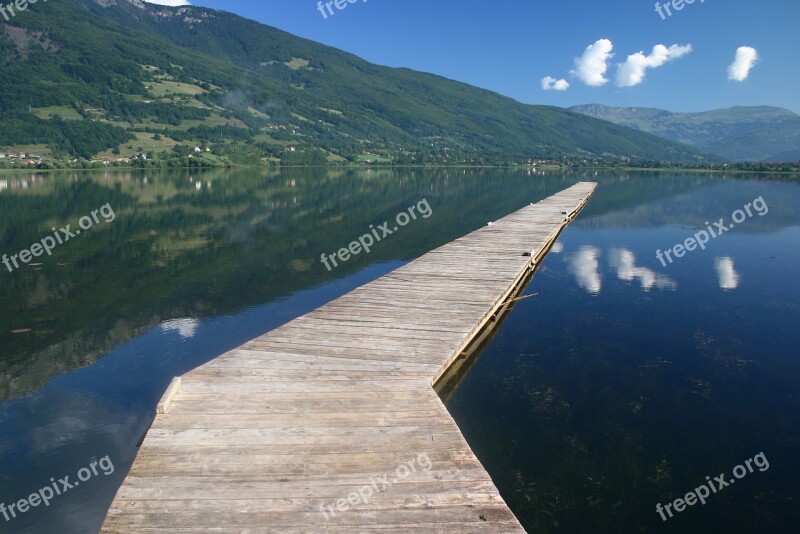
[{"xmin": 0, "ymin": 170, "xmax": 800, "ymax": 532}]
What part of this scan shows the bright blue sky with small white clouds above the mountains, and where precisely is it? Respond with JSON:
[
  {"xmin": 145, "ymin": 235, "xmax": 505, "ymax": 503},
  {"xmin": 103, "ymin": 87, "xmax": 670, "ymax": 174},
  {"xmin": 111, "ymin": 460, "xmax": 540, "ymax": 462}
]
[{"xmin": 152, "ymin": 0, "xmax": 800, "ymax": 112}]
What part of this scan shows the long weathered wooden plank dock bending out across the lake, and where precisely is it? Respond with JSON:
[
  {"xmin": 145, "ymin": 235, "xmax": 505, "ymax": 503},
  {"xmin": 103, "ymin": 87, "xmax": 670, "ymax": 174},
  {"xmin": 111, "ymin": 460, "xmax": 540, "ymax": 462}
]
[{"xmin": 102, "ymin": 182, "xmax": 596, "ymax": 534}]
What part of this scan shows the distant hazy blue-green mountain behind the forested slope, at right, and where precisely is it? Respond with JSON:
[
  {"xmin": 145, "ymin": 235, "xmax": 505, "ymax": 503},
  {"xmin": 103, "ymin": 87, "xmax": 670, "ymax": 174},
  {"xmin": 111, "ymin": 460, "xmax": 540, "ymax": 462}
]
[{"xmin": 570, "ymin": 104, "xmax": 800, "ymax": 162}]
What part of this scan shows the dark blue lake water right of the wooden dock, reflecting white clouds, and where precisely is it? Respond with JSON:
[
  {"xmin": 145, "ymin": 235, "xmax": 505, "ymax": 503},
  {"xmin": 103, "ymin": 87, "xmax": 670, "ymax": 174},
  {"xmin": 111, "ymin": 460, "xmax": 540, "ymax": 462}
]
[{"xmin": 447, "ymin": 174, "xmax": 800, "ymax": 533}]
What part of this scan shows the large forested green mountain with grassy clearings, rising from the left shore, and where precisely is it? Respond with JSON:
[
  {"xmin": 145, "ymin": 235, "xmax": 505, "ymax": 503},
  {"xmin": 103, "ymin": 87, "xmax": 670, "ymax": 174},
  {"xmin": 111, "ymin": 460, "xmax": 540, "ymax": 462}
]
[{"xmin": 0, "ymin": 0, "xmax": 705, "ymax": 165}]
